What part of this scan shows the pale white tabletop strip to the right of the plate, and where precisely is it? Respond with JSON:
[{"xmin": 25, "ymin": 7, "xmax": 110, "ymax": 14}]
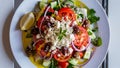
[{"xmin": 109, "ymin": 0, "xmax": 120, "ymax": 68}]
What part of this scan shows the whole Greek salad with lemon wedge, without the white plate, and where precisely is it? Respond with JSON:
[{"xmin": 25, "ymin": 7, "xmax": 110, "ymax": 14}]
[{"xmin": 20, "ymin": 0, "xmax": 102, "ymax": 68}]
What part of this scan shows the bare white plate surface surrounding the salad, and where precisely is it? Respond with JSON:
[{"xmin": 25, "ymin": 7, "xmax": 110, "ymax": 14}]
[{"xmin": 10, "ymin": 0, "xmax": 110, "ymax": 68}]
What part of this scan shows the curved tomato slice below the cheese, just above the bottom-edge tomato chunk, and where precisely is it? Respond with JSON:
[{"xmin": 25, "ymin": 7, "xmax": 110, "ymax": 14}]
[{"xmin": 54, "ymin": 52, "xmax": 72, "ymax": 62}]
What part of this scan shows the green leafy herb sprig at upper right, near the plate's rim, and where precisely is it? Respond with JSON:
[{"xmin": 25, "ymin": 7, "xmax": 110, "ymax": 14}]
[{"xmin": 88, "ymin": 9, "xmax": 100, "ymax": 24}]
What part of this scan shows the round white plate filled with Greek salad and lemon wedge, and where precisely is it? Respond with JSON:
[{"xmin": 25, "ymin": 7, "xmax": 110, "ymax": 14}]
[{"xmin": 10, "ymin": 0, "xmax": 110, "ymax": 68}]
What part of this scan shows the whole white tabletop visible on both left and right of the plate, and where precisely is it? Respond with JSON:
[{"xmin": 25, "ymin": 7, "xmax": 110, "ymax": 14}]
[{"xmin": 0, "ymin": 0, "xmax": 120, "ymax": 68}]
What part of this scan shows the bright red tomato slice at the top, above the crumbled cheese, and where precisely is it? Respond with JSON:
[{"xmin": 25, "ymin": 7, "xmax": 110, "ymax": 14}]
[{"xmin": 58, "ymin": 7, "xmax": 76, "ymax": 20}]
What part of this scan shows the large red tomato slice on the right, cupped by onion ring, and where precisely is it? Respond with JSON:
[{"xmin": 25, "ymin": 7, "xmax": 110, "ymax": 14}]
[{"xmin": 72, "ymin": 26, "xmax": 90, "ymax": 51}]
